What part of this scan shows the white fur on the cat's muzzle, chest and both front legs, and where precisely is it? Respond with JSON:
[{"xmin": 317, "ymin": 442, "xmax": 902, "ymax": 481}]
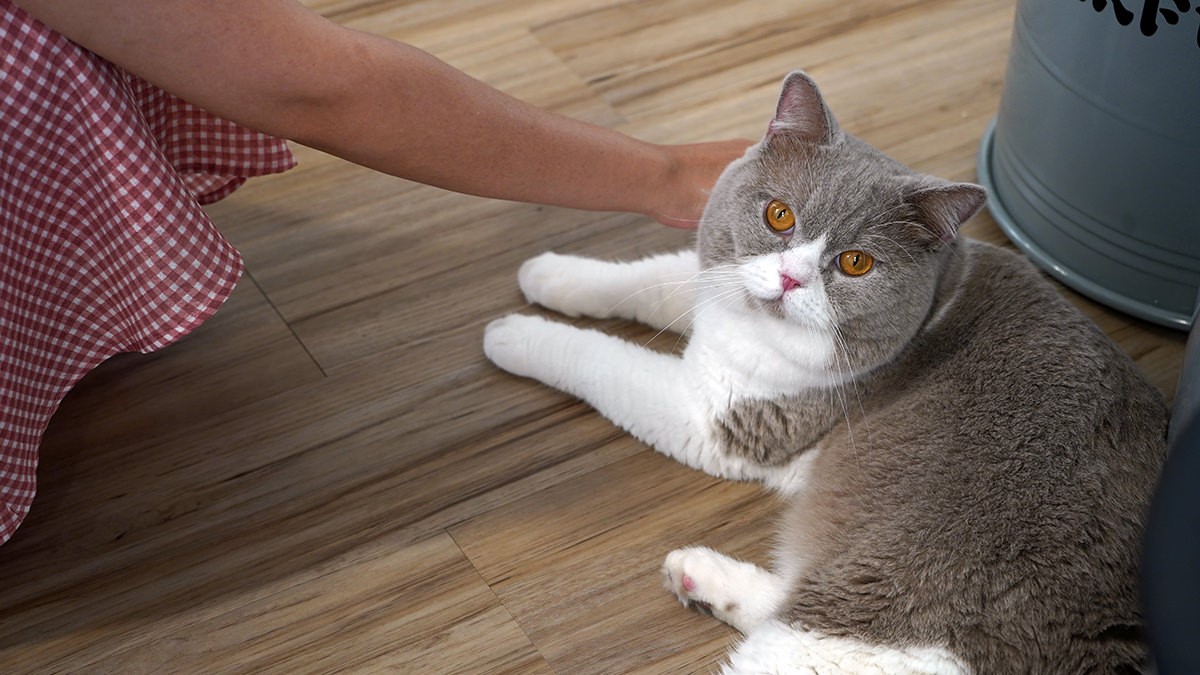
[{"xmin": 484, "ymin": 243, "xmax": 833, "ymax": 492}]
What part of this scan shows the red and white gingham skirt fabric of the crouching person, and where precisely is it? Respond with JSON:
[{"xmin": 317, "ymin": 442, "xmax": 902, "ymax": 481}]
[{"xmin": 0, "ymin": 0, "xmax": 295, "ymax": 543}]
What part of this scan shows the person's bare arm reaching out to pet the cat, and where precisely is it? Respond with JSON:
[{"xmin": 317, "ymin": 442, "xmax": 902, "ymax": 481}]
[{"xmin": 17, "ymin": 0, "xmax": 748, "ymax": 226}]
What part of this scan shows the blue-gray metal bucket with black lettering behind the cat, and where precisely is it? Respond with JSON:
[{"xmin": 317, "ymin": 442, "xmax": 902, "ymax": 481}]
[{"xmin": 979, "ymin": 0, "xmax": 1200, "ymax": 329}]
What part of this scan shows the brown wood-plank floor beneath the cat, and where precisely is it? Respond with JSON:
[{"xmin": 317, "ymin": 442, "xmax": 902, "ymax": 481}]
[{"xmin": 0, "ymin": 0, "xmax": 1183, "ymax": 675}]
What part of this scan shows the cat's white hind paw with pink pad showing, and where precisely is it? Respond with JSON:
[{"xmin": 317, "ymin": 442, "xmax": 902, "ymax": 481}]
[{"xmin": 662, "ymin": 546, "xmax": 786, "ymax": 633}]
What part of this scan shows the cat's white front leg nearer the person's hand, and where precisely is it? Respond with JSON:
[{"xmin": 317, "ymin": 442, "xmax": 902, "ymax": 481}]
[{"xmin": 517, "ymin": 250, "xmax": 700, "ymax": 333}]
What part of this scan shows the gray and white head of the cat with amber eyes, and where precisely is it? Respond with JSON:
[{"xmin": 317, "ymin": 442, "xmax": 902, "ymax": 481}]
[{"xmin": 700, "ymin": 72, "xmax": 986, "ymax": 372}]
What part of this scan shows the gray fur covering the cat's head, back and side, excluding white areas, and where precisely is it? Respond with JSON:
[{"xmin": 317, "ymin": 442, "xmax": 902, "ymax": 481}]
[{"xmin": 700, "ymin": 70, "xmax": 1166, "ymax": 673}]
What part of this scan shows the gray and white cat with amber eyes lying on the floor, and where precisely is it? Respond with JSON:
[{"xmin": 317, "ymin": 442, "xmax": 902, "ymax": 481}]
[{"xmin": 484, "ymin": 71, "xmax": 1168, "ymax": 674}]
